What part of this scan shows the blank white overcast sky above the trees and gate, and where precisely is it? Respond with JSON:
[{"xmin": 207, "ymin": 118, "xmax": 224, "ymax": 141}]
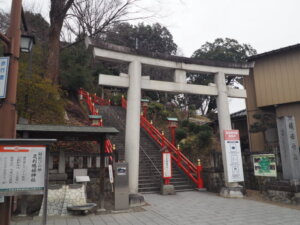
[{"xmin": 0, "ymin": 0, "xmax": 300, "ymax": 112}]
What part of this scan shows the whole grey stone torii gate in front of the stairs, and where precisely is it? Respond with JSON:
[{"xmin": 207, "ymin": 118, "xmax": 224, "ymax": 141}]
[{"xmin": 85, "ymin": 38, "xmax": 253, "ymax": 197}]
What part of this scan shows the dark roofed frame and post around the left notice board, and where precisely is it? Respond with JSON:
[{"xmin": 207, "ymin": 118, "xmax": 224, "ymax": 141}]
[{"xmin": 0, "ymin": 138, "xmax": 57, "ymax": 225}]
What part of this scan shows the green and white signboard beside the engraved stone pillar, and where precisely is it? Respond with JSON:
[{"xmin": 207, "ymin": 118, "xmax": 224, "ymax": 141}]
[{"xmin": 252, "ymin": 154, "xmax": 277, "ymax": 177}]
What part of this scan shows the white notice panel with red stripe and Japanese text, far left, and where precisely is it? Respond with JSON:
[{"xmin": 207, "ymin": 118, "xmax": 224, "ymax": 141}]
[{"xmin": 0, "ymin": 145, "xmax": 46, "ymax": 195}]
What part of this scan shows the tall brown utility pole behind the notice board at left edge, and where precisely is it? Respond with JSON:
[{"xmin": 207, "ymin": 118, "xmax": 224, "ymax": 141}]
[{"xmin": 0, "ymin": 0, "xmax": 22, "ymax": 225}]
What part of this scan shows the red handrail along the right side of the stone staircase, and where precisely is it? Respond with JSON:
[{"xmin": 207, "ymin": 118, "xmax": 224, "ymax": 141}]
[{"xmin": 122, "ymin": 96, "xmax": 204, "ymax": 188}]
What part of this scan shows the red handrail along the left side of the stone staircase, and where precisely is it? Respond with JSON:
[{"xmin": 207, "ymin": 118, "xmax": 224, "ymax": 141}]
[{"xmin": 78, "ymin": 88, "xmax": 113, "ymax": 163}]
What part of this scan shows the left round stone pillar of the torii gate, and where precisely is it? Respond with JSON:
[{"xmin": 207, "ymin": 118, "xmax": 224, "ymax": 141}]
[{"xmin": 125, "ymin": 61, "xmax": 142, "ymax": 193}]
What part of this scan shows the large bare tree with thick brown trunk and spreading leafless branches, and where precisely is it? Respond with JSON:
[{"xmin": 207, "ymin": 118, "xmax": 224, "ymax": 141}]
[{"xmin": 46, "ymin": 0, "xmax": 148, "ymax": 84}]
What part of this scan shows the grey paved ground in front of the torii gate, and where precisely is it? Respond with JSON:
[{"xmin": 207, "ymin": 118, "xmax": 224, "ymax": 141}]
[{"xmin": 13, "ymin": 191, "xmax": 300, "ymax": 225}]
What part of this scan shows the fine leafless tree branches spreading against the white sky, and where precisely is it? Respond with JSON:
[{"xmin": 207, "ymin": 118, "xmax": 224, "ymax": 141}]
[{"xmin": 65, "ymin": 0, "xmax": 140, "ymax": 39}]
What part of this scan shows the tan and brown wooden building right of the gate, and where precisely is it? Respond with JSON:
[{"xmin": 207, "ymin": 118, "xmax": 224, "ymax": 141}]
[{"xmin": 244, "ymin": 44, "xmax": 300, "ymax": 153}]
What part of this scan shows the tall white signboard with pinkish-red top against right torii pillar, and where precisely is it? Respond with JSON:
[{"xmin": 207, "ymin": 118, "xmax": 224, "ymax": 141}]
[{"xmin": 224, "ymin": 130, "xmax": 244, "ymax": 182}]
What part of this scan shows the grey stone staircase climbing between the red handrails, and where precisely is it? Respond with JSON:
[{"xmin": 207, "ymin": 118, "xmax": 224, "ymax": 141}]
[{"xmin": 99, "ymin": 106, "xmax": 194, "ymax": 193}]
